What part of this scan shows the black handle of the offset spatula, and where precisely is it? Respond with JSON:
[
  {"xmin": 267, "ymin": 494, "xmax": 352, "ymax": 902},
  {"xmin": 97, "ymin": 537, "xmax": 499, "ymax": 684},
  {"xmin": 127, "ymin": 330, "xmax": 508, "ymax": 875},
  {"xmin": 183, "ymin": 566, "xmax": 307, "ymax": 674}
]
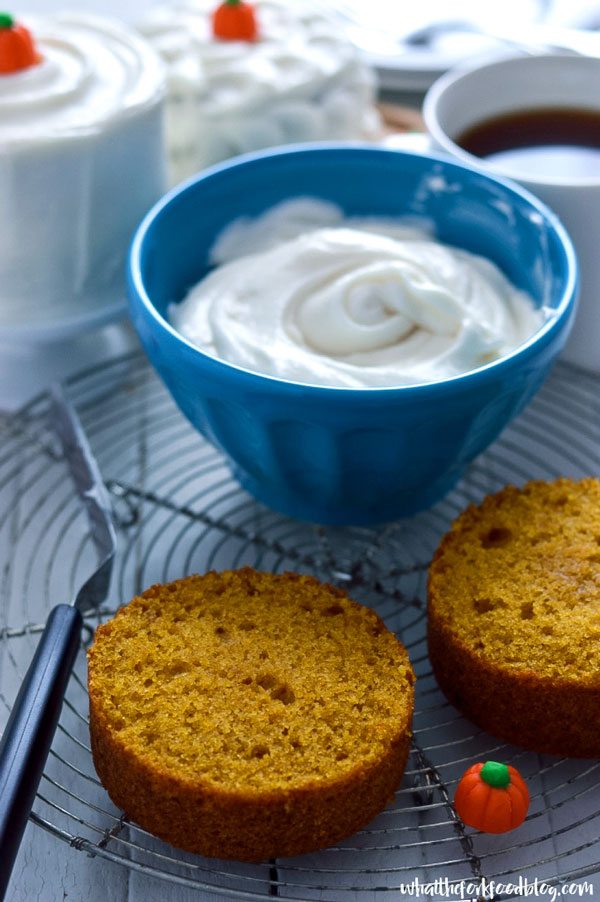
[{"xmin": 0, "ymin": 604, "xmax": 82, "ymax": 899}]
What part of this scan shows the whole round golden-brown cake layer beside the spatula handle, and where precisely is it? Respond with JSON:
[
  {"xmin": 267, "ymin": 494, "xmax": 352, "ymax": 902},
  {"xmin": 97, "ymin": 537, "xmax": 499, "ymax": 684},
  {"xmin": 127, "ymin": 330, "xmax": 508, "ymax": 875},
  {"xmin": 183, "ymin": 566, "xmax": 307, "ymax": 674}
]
[{"xmin": 89, "ymin": 568, "xmax": 414, "ymax": 861}]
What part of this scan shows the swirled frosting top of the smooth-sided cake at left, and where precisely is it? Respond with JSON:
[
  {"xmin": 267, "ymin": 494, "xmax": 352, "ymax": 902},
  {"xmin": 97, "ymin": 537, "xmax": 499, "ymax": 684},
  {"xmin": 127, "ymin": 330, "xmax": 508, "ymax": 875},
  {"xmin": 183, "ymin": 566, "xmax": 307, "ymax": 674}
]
[{"xmin": 0, "ymin": 13, "xmax": 164, "ymax": 147}]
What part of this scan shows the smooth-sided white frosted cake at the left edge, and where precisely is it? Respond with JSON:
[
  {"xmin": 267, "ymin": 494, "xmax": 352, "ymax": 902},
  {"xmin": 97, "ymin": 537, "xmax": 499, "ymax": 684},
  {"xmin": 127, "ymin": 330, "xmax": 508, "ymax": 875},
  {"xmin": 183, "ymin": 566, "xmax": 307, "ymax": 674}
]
[{"xmin": 0, "ymin": 13, "xmax": 165, "ymax": 336}]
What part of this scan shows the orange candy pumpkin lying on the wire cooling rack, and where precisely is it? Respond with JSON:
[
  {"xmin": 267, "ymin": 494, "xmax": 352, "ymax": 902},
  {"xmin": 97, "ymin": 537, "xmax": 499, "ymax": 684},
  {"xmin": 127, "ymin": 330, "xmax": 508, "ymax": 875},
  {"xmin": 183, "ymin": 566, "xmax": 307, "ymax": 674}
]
[{"xmin": 454, "ymin": 761, "xmax": 529, "ymax": 833}]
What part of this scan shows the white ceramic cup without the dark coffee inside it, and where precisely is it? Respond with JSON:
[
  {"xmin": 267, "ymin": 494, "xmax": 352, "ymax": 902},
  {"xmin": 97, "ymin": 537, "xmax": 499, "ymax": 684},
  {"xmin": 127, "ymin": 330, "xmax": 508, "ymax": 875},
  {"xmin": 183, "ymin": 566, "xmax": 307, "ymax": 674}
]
[{"xmin": 423, "ymin": 54, "xmax": 600, "ymax": 372}]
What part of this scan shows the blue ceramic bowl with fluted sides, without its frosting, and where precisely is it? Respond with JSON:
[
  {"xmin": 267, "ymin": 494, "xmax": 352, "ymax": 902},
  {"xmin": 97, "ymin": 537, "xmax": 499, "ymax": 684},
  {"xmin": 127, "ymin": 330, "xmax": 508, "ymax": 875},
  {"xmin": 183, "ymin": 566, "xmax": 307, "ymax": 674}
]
[{"xmin": 129, "ymin": 145, "xmax": 577, "ymax": 524}]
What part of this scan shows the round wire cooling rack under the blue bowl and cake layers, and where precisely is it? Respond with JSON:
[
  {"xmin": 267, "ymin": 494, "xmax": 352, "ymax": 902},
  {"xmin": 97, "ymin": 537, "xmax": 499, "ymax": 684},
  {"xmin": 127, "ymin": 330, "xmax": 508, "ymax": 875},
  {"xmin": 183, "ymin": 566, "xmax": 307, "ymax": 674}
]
[{"xmin": 0, "ymin": 354, "xmax": 600, "ymax": 902}]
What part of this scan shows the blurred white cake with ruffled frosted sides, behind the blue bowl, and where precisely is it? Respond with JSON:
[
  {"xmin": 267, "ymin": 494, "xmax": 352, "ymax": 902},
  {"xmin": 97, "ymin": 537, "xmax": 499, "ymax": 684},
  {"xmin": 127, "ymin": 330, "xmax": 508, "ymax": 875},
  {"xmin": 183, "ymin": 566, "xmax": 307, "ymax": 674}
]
[{"xmin": 139, "ymin": 0, "xmax": 379, "ymax": 183}]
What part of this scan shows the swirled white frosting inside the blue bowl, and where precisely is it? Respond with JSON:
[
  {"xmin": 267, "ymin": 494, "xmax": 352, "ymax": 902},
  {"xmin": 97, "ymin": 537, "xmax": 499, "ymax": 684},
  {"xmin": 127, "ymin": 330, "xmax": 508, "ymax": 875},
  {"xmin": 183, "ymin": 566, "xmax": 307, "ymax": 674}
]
[{"xmin": 170, "ymin": 205, "xmax": 544, "ymax": 387}]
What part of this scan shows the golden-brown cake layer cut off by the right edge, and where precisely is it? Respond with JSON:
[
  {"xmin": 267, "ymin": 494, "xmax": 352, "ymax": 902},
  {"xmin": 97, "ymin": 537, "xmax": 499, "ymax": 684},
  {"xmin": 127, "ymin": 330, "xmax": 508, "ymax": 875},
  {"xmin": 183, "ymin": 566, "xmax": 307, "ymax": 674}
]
[{"xmin": 428, "ymin": 478, "xmax": 600, "ymax": 757}]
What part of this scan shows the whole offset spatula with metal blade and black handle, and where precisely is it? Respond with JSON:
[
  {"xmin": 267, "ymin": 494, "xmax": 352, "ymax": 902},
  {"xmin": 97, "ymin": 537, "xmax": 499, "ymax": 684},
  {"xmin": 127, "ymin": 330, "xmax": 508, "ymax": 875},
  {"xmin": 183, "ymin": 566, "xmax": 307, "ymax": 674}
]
[{"xmin": 0, "ymin": 388, "xmax": 116, "ymax": 899}]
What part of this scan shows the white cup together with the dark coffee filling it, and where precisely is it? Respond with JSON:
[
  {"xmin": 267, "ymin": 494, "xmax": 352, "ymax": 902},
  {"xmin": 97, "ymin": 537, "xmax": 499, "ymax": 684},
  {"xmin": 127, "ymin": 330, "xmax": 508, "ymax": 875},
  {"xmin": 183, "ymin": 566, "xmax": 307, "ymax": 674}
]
[{"xmin": 423, "ymin": 53, "xmax": 600, "ymax": 373}]
